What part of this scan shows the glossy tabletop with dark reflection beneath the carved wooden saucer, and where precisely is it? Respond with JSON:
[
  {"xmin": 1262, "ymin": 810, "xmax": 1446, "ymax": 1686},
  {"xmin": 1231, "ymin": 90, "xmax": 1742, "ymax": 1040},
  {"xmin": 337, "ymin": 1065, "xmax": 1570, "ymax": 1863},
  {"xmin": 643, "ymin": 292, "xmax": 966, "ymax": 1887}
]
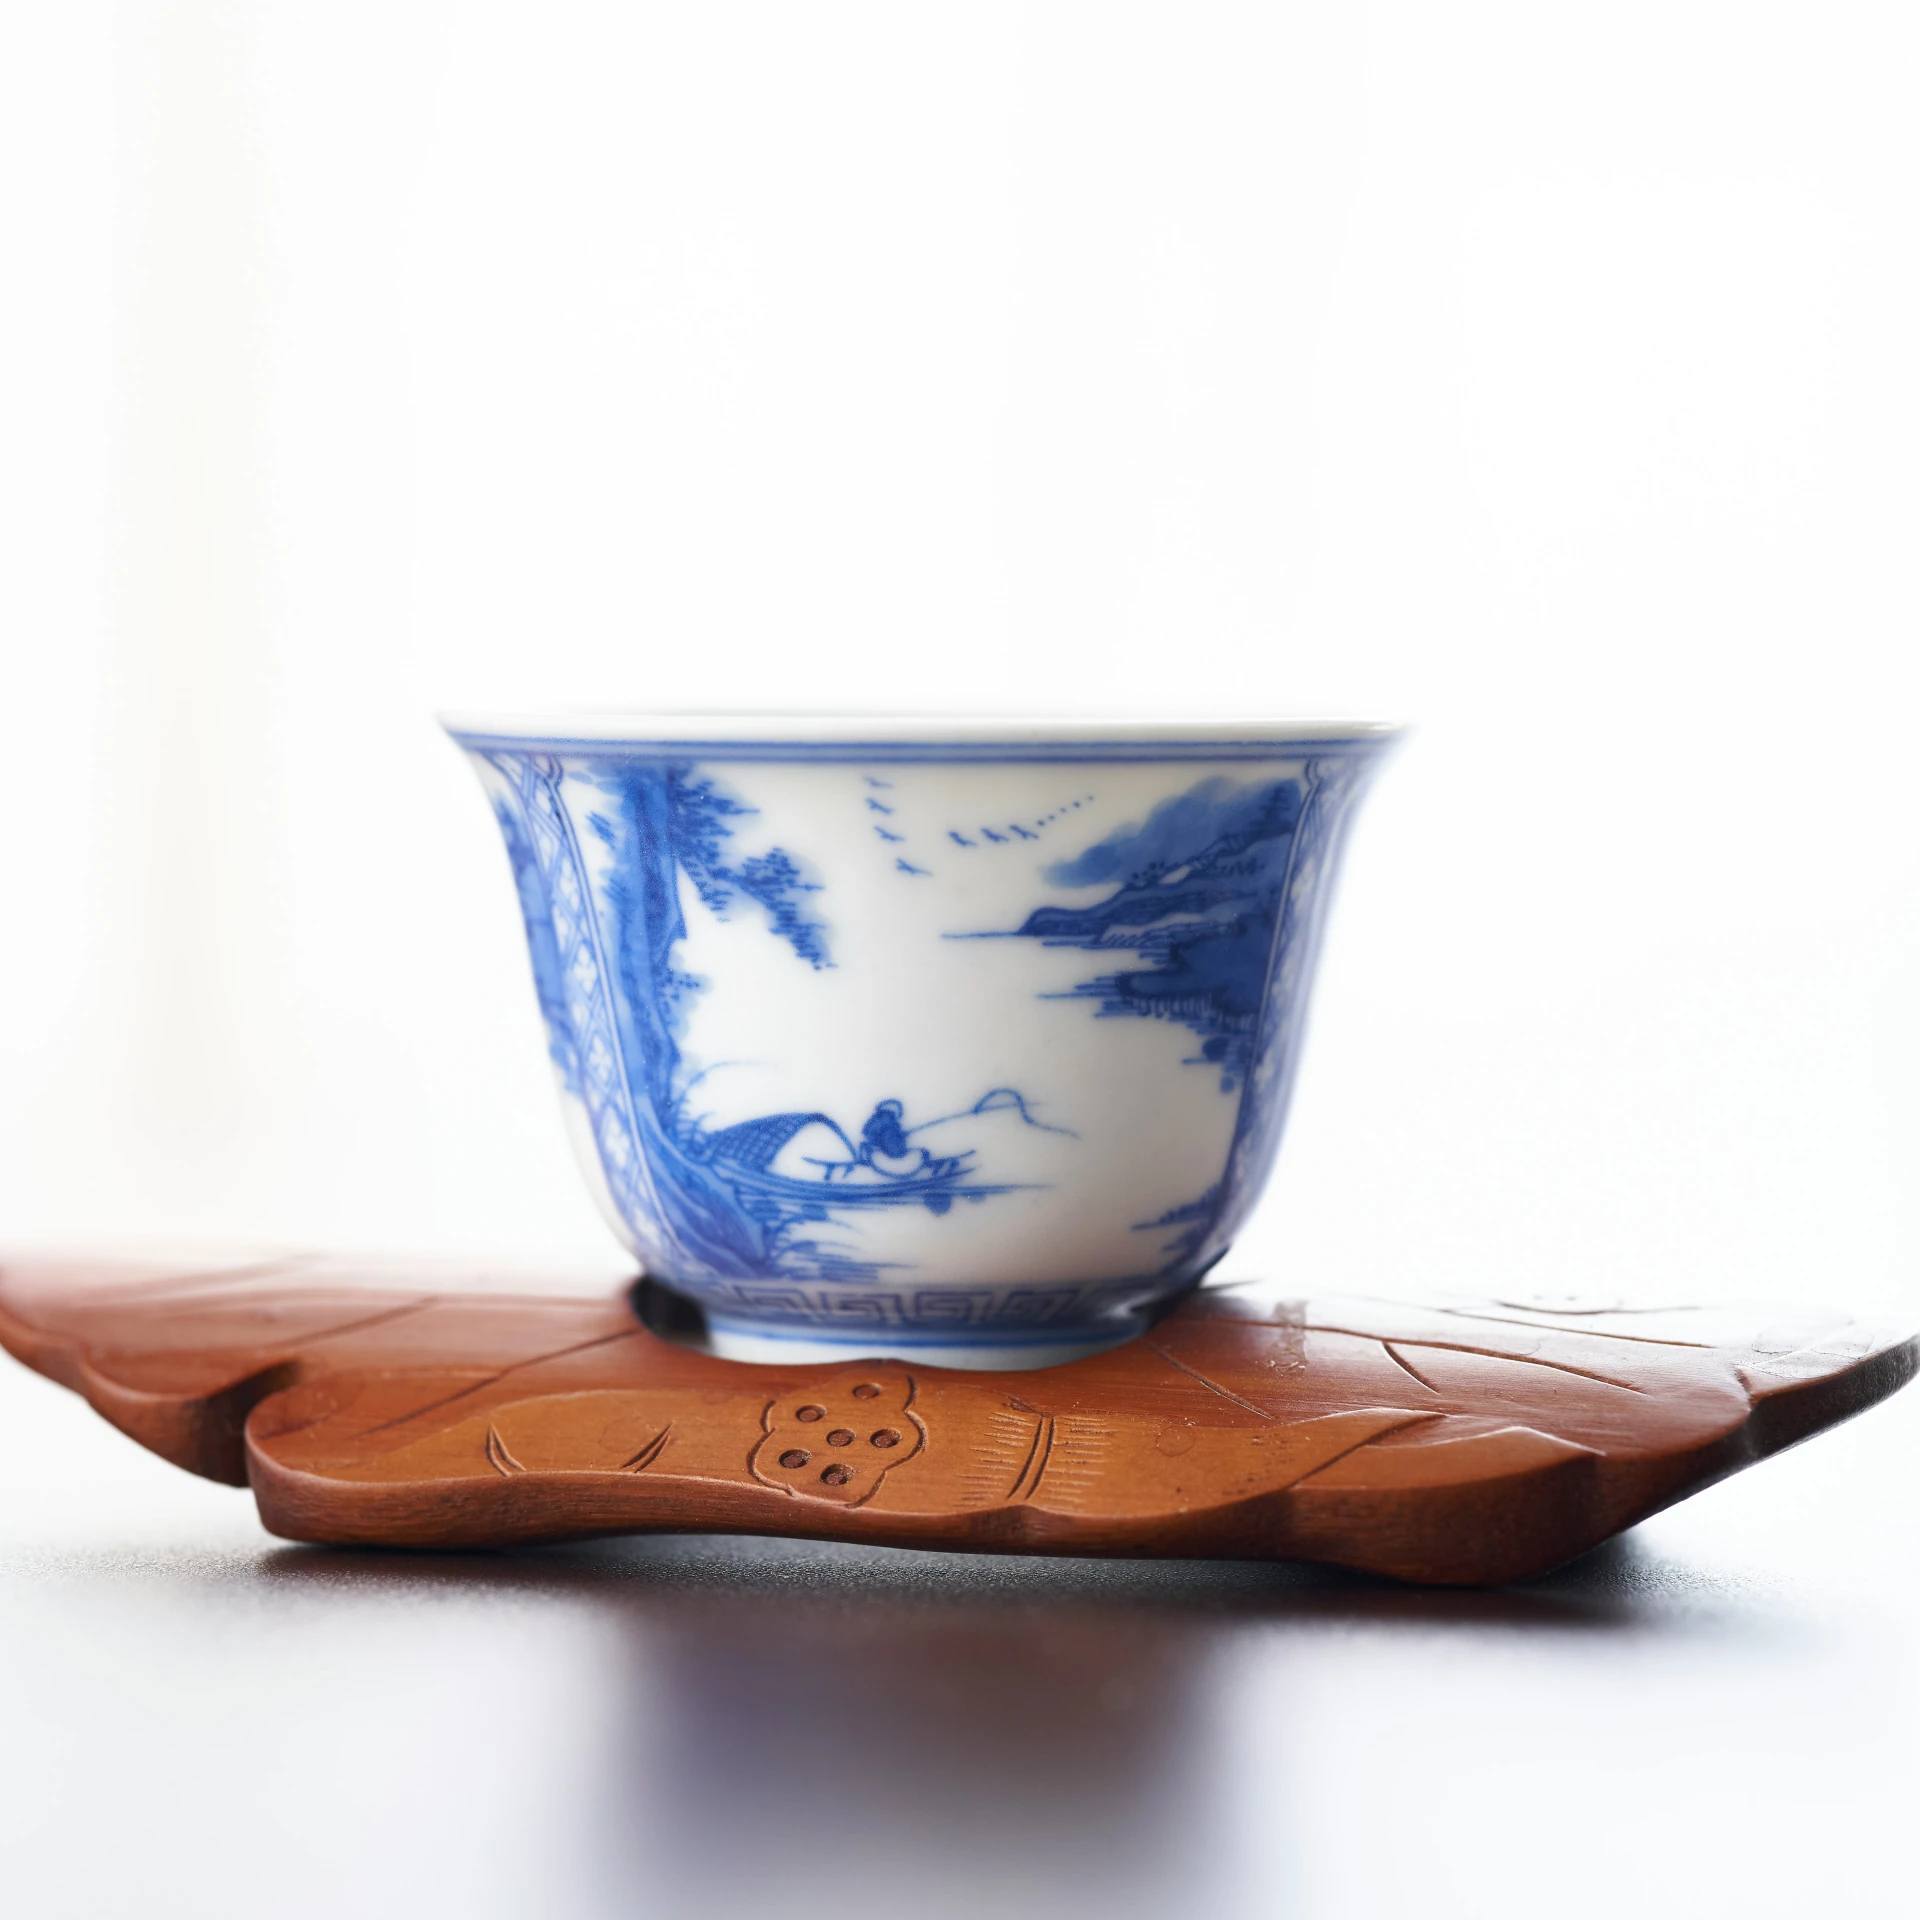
[{"xmin": 0, "ymin": 1336, "xmax": 1920, "ymax": 1920}]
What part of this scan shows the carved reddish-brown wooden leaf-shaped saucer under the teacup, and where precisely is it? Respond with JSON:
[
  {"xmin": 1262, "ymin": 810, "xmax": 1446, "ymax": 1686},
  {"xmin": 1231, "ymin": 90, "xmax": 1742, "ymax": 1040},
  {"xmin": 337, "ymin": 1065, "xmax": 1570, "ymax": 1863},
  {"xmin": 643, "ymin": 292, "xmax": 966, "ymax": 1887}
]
[{"xmin": 0, "ymin": 1260, "xmax": 1916, "ymax": 1584}]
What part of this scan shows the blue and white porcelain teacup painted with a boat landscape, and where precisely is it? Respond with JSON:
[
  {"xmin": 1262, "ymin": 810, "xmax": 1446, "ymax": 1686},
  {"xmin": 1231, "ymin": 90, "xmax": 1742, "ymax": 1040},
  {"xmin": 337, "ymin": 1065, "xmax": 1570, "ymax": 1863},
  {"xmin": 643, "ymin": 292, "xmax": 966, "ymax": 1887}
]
[{"xmin": 447, "ymin": 714, "xmax": 1392, "ymax": 1367}]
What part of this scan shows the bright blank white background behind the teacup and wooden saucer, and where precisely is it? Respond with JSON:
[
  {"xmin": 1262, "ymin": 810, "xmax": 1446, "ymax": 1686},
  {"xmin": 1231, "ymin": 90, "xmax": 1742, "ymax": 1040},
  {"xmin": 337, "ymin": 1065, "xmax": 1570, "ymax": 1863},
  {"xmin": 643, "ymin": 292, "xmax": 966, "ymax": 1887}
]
[{"xmin": 0, "ymin": 0, "xmax": 1920, "ymax": 1308}]
